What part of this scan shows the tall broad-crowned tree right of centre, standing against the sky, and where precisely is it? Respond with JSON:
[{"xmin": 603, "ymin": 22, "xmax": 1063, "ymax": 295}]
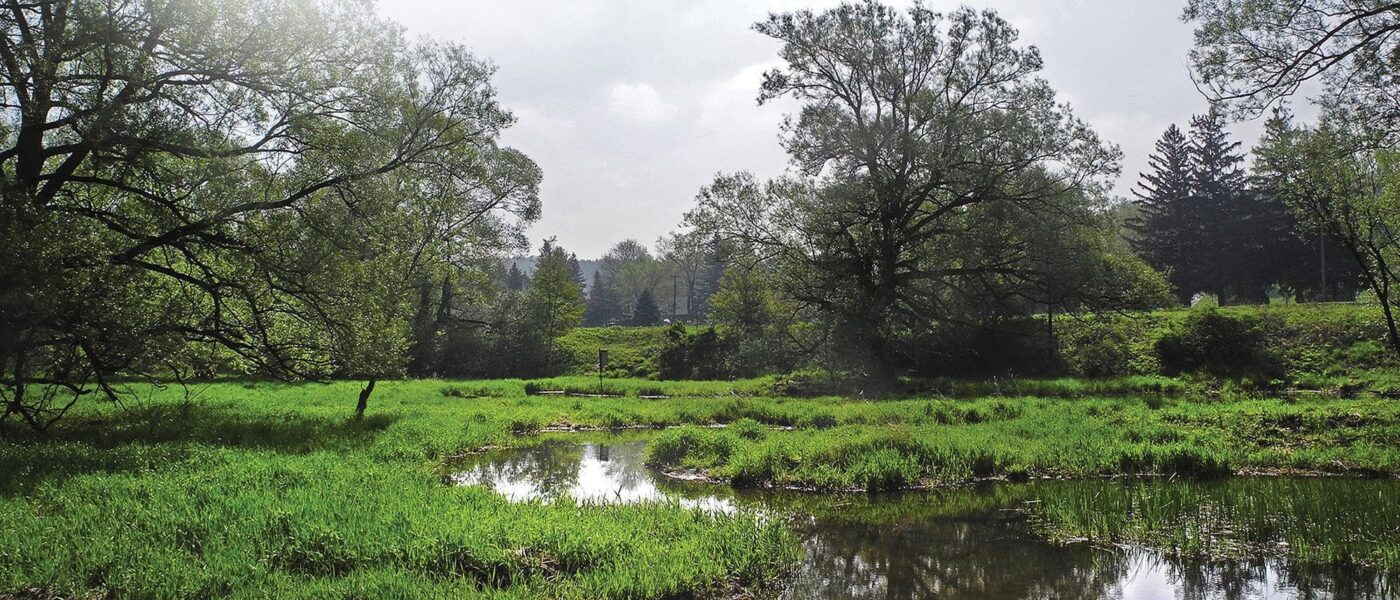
[{"xmin": 687, "ymin": 1, "xmax": 1119, "ymax": 379}]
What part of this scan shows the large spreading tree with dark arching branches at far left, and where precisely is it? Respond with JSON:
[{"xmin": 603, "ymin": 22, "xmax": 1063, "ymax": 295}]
[{"xmin": 0, "ymin": 0, "xmax": 539, "ymax": 429}]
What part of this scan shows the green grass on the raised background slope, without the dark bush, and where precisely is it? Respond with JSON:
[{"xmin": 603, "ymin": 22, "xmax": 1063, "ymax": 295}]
[{"xmin": 559, "ymin": 302, "xmax": 1400, "ymax": 397}]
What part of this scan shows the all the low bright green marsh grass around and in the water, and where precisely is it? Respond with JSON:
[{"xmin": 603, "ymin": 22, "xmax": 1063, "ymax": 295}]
[{"xmin": 0, "ymin": 378, "xmax": 1400, "ymax": 599}]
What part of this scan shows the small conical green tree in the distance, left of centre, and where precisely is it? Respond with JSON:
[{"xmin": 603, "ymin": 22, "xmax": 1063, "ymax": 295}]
[{"xmin": 525, "ymin": 239, "xmax": 584, "ymax": 369}]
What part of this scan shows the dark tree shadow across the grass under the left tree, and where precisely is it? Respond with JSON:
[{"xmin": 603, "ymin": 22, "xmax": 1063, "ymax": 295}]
[{"xmin": 0, "ymin": 403, "xmax": 398, "ymax": 495}]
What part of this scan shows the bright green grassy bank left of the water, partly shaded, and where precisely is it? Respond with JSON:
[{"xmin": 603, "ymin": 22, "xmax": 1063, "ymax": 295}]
[{"xmin": 0, "ymin": 382, "xmax": 795, "ymax": 599}]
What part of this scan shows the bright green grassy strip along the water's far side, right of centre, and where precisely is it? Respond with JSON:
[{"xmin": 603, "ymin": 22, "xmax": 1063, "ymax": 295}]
[{"xmin": 650, "ymin": 397, "xmax": 1400, "ymax": 490}]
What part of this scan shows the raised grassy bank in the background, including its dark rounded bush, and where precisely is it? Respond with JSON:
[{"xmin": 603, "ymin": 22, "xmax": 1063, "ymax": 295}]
[{"xmin": 560, "ymin": 303, "xmax": 1400, "ymax": 394}]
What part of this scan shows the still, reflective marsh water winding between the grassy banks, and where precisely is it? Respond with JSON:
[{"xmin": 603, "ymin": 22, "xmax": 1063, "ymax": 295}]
[{"xmin": 452, "ymin": 441, "xmax": 1400, "ymax": 600}]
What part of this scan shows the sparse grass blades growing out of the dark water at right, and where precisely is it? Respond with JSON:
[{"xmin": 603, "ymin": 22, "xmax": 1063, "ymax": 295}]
[{"xmin": 1030, "ymin": 478, "xmax": 1400, "ymax": 571}]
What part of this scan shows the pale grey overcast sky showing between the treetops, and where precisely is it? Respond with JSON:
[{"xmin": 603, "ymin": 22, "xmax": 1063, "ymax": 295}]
[{"xmin": 381, "ymin": 0, "xmax": 1282, "ymax": 257}]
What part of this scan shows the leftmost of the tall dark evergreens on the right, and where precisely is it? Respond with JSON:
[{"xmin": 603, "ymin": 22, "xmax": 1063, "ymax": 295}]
[{"xmin": 1127, "ymin": 124, "xmax": 1198, "ymax": 303}]
